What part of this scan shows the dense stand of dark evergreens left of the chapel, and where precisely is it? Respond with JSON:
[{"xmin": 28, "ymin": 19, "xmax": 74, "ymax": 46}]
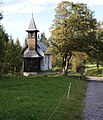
[{"xmin": 0, "ymin": 13, "xmax": 22, "ymax": 74}]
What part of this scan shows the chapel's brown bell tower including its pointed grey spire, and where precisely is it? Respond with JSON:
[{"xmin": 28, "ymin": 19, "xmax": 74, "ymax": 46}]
[{"xmin": 26, "ymin": 14, "xmax": 39, "ymax": 51}]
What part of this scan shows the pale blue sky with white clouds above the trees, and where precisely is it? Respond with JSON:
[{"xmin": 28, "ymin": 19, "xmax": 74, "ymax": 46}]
[{"xmin": 0, "ymin": 0, "xmax": 103, "ymax": 45}]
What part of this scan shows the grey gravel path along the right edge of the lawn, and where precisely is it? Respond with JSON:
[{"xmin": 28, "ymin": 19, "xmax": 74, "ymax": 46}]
[{"xmin": 84, "ymin": 77, "xmax": 103, "ymax": 120}]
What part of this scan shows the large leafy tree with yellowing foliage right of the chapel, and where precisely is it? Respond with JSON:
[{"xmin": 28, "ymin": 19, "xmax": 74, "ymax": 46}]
[{"xmin": 51, "ymin": 1, "xmax": 96, "ymax": 74}]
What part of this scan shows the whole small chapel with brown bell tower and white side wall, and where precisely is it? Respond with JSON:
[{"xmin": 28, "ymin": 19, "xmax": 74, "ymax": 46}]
[{"xmin": 22, "ymin": 15, "xmax": 52, "ymax": 75}]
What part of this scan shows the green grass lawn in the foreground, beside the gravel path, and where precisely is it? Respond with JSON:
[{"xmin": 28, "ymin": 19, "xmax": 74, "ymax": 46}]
[{"xmin": 0, "ymin": 75, "xmax": 87, "ymax": 120}]
